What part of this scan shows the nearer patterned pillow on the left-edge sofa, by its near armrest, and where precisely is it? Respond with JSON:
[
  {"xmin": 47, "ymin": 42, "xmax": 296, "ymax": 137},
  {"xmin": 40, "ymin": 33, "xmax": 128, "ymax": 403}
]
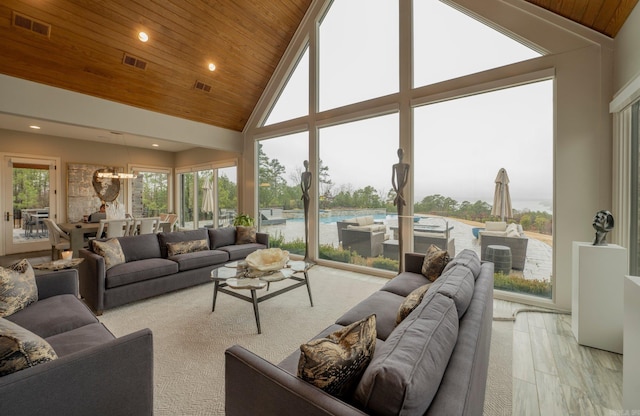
[{"xmin": 0, "ymin": 318, "xmax": 58, "ymax": 377}]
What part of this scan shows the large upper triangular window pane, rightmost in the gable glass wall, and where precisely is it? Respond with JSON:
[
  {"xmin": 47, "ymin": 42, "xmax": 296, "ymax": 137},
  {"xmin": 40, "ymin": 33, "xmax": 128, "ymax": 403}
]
[{"xmin": 413, "ymin": 0, "xmax": 541, "ymax": 87}]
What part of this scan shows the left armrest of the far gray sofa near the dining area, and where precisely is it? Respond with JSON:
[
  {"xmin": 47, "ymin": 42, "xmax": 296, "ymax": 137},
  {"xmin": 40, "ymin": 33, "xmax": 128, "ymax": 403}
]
[{"xmin": 78, "ymin": 249, "xmax": 106, "ymax": 315}]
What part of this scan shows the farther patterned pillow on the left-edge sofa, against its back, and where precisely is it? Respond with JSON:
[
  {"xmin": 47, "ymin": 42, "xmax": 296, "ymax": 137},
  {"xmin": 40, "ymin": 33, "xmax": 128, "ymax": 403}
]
[{"xmin": 0, "ymin": 259, "xmax": 38, "ymax": 317}]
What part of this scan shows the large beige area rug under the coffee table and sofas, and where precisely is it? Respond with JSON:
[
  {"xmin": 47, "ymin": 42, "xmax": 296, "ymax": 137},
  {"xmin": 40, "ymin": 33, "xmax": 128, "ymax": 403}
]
[{"xmin": 99, "ymin": 266, "xmax": 513, "ymax": 416}]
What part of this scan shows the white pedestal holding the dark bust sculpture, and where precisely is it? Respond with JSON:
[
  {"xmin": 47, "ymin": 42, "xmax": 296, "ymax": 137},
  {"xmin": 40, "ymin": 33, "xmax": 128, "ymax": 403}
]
[{"xmin": 571, "ymin": 241, "xmax": 629, "ymax": 354}]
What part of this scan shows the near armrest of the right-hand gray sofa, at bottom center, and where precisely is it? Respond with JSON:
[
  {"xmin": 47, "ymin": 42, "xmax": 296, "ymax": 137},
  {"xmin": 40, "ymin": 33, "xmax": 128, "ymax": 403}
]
[{"xmin": 224, "ymin": 345, "xmax": 365, "ymax": 416}]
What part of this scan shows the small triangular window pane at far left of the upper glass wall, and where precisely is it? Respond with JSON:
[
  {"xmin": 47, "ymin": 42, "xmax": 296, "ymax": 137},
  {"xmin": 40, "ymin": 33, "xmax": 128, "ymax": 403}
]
[{"xmin": 264, "ymin": 48, "xmax": 309, "ymax": 126}]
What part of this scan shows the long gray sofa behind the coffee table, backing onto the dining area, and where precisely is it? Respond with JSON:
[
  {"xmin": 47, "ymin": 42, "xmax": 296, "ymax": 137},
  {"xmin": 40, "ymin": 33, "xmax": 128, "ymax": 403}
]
[{"xmin": 79, "ymin": 227, "xmax": 269, "ymax": 315}]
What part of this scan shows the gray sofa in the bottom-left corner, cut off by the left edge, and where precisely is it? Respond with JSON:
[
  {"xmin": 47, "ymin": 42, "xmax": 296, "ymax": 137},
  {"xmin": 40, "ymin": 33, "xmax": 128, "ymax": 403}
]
[{"xmin": 0, "ymin": 269, "xmax": 154, "ymax": 416}]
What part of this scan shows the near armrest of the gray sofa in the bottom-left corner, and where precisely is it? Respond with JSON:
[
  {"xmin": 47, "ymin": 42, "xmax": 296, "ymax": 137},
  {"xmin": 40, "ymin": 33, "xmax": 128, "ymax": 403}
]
[{"xmin": 0, "ymin": 329, "xmax": 154, "ymax": 416}]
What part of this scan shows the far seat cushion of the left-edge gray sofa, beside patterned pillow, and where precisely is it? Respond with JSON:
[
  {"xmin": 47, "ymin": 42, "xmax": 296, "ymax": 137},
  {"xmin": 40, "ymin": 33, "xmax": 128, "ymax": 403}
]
[{"xmin": 6, "ymin": 294, "xmax": 98, "ymax": 339}]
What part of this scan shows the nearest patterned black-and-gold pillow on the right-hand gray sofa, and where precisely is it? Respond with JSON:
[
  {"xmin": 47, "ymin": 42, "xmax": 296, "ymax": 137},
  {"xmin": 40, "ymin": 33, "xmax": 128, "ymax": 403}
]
[{"xmin": 298, "ymin": 315, "xmax": 377, "ymax": 397}]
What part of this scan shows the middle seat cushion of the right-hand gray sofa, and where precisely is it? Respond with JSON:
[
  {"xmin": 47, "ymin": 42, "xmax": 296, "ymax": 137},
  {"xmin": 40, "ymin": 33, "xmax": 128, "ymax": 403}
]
[{"xmin": 336, "ymin": 290, "xmax": 404, "ymax": 341}]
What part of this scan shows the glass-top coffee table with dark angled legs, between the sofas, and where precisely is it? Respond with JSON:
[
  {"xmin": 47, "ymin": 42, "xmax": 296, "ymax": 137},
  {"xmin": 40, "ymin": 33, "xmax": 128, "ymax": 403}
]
[{"xmin": 211, "ymin": 261, "xmax": 315, "ymax": 334}]
